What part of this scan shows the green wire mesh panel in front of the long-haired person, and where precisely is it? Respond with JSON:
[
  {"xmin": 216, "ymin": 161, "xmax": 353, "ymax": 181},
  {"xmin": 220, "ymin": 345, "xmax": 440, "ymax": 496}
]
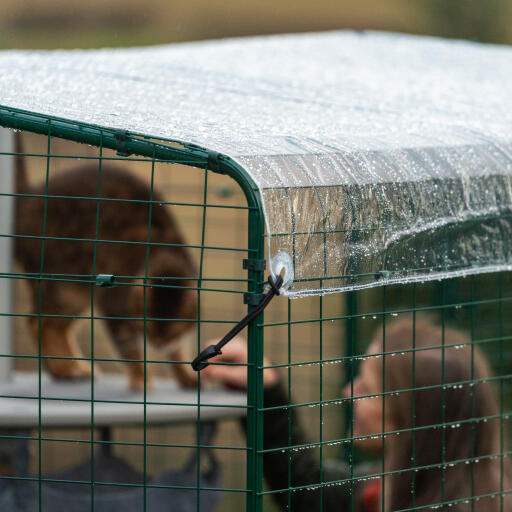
[{"xmin": 261, "ymin": 273, "xmax": 512, "ymax": 511}]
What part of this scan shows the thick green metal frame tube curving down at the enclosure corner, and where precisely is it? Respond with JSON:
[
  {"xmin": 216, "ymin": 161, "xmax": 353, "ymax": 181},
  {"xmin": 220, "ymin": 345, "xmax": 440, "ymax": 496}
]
[{"xmin": 0, "ymin": 106, "xmax": 265, "ymax": 512}]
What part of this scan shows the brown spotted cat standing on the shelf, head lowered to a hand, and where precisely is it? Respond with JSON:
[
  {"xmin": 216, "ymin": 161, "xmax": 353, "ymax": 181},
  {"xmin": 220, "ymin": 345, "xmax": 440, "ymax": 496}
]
[{"xmin": 14, "ymin": 134, "xmax": 197, "ymax": 391}]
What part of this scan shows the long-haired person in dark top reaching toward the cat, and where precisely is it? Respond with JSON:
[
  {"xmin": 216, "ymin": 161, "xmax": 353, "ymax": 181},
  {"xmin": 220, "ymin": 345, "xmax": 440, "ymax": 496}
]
[{"xmin": 203, "ymin": 315, "xmax": 512, "ymax": 512}]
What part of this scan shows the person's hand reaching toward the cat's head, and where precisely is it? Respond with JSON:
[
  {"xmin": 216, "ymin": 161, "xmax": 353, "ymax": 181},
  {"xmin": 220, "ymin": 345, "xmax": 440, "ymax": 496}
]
[{"xmin": 201, "ymin": 337, "xmax": 279, "ymax": 389}]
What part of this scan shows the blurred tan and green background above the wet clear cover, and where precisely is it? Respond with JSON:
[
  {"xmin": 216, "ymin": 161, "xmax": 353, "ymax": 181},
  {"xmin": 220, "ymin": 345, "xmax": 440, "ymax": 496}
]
[{"xmin": 0, "ymin": 0, "xmax": 512, "ymax": 48}]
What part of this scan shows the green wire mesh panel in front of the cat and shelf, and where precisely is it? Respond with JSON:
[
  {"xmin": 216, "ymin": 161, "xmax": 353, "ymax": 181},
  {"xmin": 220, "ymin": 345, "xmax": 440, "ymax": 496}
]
[{"xmin": 0, "ymin": 112, "xmax": 263, "ymax": 511}]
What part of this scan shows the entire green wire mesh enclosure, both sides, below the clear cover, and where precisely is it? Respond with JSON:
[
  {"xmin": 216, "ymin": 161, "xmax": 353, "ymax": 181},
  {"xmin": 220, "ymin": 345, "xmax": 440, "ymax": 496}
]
[{"xmin": 0, "ymin": 111, "xmax": 512, "ymax": 512}]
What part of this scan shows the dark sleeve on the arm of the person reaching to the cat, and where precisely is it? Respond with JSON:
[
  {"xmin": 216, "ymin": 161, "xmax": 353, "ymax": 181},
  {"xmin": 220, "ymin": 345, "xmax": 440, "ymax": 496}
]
[{"xmin": 250, "ymin": 383, "xmax": 380, "ymax": 512}]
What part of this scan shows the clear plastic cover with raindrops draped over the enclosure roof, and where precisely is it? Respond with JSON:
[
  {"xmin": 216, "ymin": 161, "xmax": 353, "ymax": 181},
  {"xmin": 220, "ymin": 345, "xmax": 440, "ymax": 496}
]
[{"xmin": 0, "ymin": 32, "xmax": 512, "ymax": 296}]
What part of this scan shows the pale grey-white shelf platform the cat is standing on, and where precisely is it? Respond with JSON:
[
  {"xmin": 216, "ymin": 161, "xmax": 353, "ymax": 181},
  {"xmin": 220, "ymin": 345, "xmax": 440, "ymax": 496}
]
[{"xmin": 0, "ymin": 372, "xmax": 247, "ymax": 428}]
